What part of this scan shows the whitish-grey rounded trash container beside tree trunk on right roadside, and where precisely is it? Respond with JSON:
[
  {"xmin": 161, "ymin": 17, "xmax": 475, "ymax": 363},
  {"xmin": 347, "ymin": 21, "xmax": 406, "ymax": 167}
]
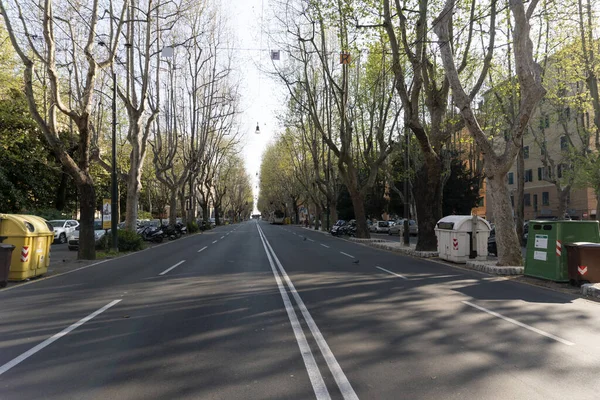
[{"xmin": 435, "ymin": 215, "xmax": 492, "ymax": 264}]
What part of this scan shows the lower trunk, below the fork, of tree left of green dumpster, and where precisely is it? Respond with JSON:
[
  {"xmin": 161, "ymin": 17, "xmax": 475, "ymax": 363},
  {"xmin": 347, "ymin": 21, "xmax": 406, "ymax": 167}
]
[{"xmin": 487, "ymin": 169, "xmax": 523, "ymax": 266}]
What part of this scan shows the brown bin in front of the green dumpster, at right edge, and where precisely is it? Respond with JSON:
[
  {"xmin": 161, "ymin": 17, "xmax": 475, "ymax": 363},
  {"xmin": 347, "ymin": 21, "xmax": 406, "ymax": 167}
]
[{"xmin": 566, "ymin": 242, "xmax": 600, "ymax": 285}]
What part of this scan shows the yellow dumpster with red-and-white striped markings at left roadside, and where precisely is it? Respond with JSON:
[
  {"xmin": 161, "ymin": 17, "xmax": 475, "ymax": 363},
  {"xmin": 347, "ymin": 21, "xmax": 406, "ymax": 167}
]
[{"xmin": 0, "ymin": 214, "xmax": 54, "ymax": 281}]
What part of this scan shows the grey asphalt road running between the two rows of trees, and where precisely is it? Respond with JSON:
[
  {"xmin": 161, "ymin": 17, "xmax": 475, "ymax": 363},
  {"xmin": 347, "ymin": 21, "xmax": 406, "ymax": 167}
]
[{"xmin": 0, "ymin": 222, "xmax": 600, "ymax": 400}]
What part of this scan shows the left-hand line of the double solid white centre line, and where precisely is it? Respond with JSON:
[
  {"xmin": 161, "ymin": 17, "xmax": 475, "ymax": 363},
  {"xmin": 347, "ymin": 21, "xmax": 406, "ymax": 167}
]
[{"xmin": 256, "ymin": 224, "xmax": 331, "ymax": 400}]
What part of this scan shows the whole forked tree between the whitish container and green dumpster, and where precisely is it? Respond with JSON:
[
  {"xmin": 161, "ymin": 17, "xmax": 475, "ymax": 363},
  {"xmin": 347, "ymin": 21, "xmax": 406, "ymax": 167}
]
[{"xmin": 434, "ymin": 0, "xmax": 546, "ymax": 265}]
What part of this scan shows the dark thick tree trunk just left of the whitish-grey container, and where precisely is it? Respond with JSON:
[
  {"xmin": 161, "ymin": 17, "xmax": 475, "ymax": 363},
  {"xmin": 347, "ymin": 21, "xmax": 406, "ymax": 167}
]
[{"xmin": 414, "ymin": 161, "xmax": 443, "ymax": 251}]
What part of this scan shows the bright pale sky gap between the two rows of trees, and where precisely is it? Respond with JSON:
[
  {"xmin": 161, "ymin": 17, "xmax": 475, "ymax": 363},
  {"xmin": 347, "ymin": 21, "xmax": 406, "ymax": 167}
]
[{"xmin": 230, "ymin": 0, "xmax": 285, "ymax": 213}]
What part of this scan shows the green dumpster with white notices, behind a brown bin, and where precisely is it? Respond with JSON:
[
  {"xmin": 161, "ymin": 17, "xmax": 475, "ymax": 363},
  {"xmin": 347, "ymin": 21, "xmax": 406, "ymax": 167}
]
[{"xmin": 524, "ymin": 221, "xmax": 600, "ymax": 282}]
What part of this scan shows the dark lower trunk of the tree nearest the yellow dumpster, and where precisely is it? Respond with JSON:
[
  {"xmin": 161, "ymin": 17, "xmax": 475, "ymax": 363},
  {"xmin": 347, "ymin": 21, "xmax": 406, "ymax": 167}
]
[{"xmin": 77, "ymin": 178, "xmax": 96, "ymax": 260}]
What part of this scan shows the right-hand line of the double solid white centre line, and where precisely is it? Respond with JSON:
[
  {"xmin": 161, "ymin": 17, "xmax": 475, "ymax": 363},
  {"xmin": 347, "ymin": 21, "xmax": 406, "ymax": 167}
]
[{"xmin": 259, "ymin": 227, "xmax": 358, "ymax": 400}]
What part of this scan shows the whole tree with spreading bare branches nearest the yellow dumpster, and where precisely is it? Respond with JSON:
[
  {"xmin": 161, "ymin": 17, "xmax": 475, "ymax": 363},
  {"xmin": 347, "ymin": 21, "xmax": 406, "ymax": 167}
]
[{"xmin": 0, "ymin": 0, "xmax": 127, "ymax": 259}]
